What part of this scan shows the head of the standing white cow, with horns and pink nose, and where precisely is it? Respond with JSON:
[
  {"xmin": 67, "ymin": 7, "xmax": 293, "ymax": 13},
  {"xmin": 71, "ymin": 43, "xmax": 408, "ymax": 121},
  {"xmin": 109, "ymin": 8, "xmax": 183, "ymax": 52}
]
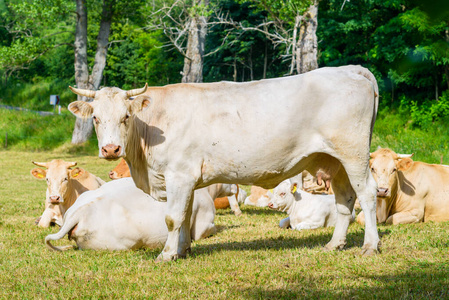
[{"xmin": 68, "ymin": 84, "xmax": 150, "ymax": 160}]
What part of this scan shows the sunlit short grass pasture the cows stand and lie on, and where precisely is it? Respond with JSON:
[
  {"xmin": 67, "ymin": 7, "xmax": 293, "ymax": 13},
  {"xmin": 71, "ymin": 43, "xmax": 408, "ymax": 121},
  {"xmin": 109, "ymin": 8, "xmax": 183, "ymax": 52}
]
[{"xmin": 0, "ymin": 151, "xmax": 449, "ymax": 299}]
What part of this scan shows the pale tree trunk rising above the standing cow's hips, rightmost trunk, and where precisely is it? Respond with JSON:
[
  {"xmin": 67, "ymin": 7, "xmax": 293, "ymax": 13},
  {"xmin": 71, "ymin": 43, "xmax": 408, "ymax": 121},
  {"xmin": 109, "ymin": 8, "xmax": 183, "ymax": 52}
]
[{"xmin": 296, "ymin": 0, "xmax": 318, "ymax": 74}]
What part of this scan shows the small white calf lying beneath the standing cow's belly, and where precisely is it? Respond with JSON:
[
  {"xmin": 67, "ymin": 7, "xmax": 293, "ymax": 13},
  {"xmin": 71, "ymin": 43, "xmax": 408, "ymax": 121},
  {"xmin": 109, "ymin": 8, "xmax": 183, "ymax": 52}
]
[{"xmin": 268, "ymin": 179, "xmax": 344, "ymax": 230}]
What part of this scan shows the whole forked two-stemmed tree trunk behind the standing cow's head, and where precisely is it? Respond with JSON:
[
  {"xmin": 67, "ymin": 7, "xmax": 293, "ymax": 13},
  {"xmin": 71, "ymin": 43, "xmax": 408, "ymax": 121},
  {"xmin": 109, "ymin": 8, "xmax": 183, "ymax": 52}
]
[{"xmin": 72, "ymin": 0, "xmax": 115, "ymax": 144}]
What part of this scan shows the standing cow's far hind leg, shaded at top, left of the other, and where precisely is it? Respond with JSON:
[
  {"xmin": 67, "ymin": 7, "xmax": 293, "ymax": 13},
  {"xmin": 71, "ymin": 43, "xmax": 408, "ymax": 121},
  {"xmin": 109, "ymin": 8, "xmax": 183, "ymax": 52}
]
[{"xmin": 325, "ymin": 168, "xmax": 356, "ymax": 250}]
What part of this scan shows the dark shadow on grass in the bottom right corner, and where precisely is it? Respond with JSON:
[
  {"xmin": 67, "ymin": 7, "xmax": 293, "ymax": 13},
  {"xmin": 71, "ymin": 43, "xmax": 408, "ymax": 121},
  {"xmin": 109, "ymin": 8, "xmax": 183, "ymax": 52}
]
[{"xmin": 239, "ymin": 263, "xmax": 449, "ymax": 299}]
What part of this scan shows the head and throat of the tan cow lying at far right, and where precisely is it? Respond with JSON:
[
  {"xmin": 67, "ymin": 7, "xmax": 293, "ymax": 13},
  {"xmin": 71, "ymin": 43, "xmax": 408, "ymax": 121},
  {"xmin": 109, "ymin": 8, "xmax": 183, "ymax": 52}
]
[{"xmin": 370, "ymin": 148, "xmax": 413, "ymax": 223}]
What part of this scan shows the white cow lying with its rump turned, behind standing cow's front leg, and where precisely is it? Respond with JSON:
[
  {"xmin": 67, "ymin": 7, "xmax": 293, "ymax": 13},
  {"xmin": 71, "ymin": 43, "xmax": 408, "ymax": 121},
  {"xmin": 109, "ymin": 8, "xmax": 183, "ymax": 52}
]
[{"xmin": 45, "ymin": 178, "xmax": 236, "ymax": 250}]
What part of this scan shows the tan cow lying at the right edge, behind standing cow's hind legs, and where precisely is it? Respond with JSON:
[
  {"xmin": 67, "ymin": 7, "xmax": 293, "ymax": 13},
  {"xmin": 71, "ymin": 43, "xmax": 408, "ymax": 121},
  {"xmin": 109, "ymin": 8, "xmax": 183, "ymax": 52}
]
[{"xmin": 357, "ymin": 148, "xmax": 449, "ymax": 225}]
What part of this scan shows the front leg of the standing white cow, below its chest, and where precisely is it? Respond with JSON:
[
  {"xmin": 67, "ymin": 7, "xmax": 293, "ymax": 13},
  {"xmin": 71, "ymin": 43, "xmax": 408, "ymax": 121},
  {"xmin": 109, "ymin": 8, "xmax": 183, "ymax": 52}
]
[{"xmin": 156, "ymin": 176, "xmax": 194, "ymax": 261}]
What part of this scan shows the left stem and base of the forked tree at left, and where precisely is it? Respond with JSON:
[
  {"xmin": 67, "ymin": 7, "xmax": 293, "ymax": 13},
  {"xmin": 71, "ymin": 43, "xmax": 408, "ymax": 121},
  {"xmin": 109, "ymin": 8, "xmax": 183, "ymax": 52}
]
[{"xmin": 72, "ymin": 0, "xmax": 93, "ymax": 144}]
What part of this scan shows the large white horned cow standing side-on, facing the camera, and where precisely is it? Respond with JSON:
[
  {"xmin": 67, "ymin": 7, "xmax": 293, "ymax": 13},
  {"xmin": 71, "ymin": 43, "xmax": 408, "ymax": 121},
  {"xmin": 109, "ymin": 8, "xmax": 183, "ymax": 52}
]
[{"xmin": 69, "ymin": 66, "xmax": 379, "ymax": 261}]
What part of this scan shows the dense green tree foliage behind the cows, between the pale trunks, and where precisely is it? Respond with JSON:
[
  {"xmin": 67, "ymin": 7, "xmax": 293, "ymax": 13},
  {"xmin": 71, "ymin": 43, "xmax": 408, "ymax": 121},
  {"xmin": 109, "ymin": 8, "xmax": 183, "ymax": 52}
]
[{"xmin": 0, "ymin": 0, "xmax": 449, "ymax": 126}]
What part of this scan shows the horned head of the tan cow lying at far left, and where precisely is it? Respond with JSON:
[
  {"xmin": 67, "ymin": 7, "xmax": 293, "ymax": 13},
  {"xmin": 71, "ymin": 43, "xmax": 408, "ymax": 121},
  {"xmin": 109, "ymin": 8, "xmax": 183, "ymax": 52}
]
[{"xmin": 31, "ymin": 159, "xmax": 82, "ymax": 204}]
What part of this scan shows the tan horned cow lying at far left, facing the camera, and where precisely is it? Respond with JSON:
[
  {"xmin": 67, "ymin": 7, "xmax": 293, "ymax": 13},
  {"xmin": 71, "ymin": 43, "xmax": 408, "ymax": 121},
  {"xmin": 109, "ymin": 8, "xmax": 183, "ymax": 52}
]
[{"xmin": 31, "ymin": 159, "xmax": 104, "ymax": 228}]
